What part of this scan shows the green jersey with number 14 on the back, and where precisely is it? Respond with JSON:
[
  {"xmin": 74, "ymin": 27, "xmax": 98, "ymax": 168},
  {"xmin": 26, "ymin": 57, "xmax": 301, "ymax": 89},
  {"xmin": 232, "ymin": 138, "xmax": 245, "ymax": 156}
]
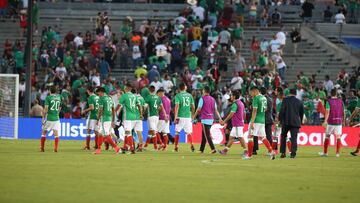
[{"xmin": 119, "ymin": 92, "xmax": 138, "ymax": 121}]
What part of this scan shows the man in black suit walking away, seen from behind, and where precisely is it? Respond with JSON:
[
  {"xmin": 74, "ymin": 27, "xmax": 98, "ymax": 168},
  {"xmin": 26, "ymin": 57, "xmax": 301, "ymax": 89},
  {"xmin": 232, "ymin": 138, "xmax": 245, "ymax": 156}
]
[{"xmin": 279, "ymin": 89, "xmax": 304, "ymax": 158}]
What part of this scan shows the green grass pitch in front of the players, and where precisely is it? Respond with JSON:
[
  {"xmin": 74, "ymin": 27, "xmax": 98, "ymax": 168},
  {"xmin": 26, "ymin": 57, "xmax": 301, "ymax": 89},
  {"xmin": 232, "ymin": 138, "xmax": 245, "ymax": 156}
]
[{"xmin": 0, "ymin": 139, "xmax": 360, "ymax": 203}]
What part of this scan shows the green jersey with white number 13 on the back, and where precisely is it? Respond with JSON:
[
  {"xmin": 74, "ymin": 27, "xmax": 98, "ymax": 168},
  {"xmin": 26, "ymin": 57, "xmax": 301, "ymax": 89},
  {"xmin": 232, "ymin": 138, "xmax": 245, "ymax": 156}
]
[{"xmin": 175, "ymin": 92, "xmax": 195, "ymax": 118}]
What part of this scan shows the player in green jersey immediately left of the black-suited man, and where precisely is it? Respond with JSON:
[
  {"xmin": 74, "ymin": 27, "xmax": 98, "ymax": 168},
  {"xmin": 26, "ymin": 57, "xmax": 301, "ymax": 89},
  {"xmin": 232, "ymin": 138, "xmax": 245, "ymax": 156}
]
[{"xmin": 244, "ymin": 86, "xmax": 275, "ymax": 160}]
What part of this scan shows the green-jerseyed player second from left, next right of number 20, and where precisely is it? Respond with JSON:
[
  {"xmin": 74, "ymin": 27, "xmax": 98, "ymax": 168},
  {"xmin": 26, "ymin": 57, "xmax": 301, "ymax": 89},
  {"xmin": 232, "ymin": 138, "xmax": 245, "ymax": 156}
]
[{"xmin": 83, "ymin": 86, "xmax": 99, "ymax": 150}]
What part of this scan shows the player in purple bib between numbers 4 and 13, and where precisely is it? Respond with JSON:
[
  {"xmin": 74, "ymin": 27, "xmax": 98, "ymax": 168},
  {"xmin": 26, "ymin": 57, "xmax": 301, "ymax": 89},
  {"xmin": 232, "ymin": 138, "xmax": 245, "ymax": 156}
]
[{"xmin": 157, "ymin": 88, "xmax": 171, "ymax": 151}]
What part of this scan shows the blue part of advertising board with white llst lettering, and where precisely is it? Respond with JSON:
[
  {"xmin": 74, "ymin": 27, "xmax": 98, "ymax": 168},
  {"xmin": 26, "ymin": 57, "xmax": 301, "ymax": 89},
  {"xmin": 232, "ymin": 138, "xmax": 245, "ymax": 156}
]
[{"xmin": 18, "ymin": 118, "xmax": 186, "ymax": 142}]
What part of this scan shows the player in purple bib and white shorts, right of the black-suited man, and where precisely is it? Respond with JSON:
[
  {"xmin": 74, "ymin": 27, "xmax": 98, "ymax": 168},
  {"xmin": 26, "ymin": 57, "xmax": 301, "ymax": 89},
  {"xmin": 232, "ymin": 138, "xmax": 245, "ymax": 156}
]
[{"xmin": 319, "ymin": 89, "xmax": 345, "ymax": 157}]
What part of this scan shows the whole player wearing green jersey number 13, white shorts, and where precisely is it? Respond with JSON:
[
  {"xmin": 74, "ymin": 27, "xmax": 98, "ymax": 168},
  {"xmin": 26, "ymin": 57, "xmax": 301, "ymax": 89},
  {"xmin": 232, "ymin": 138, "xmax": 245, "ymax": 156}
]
[{"xmin": 174, "ymin": 83, "xmax": 195, "ymax": 152}]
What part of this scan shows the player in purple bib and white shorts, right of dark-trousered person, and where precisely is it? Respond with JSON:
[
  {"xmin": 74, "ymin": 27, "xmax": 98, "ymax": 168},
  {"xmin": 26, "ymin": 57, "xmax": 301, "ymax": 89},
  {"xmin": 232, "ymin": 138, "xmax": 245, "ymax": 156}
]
[{"xmin": 219, "ymin": 91, "xmax": 247, "ymax": 156}]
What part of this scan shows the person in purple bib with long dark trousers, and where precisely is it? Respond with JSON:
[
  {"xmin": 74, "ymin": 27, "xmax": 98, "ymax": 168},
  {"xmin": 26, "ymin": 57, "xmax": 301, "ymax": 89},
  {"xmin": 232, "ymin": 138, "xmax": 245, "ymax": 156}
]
[{"xmin": 193, "ymin": 86, "xmax": 222, "ymax": 154}]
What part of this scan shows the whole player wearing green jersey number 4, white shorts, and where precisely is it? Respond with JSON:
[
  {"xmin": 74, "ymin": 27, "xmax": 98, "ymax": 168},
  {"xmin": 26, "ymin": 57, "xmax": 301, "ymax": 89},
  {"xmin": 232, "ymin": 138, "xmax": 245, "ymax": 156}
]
[{"xmin": 145, "ymin": 85, "xmax": 168, "ymax": 150}]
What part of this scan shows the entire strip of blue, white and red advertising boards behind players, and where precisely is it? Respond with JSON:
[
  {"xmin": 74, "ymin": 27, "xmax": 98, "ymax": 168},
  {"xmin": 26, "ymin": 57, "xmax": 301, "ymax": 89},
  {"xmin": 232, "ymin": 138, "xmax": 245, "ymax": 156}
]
[{"xmin": 19, "ymin": 118, "xmax": 359, "ymax": 147}]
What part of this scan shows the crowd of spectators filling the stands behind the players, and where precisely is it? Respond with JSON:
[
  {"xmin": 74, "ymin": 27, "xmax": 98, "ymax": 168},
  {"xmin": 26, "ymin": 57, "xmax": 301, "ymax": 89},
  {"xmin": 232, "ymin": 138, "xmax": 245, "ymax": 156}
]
[{"xmin": 2, "ymin": 0, "xmax": 360, "ymax": 125}]
